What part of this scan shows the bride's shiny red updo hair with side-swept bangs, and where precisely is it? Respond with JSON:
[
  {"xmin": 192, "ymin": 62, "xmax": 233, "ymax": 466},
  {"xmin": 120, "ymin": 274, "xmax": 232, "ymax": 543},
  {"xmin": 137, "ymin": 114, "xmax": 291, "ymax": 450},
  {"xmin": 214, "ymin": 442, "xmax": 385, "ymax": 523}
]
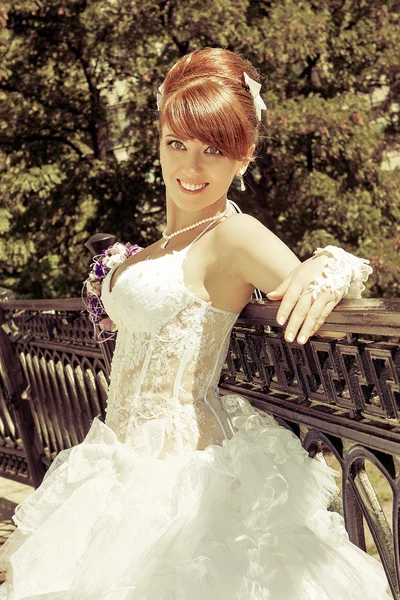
[{"xmin": 160, "ymin": 48, "xmax": 259, "ymax": 160}]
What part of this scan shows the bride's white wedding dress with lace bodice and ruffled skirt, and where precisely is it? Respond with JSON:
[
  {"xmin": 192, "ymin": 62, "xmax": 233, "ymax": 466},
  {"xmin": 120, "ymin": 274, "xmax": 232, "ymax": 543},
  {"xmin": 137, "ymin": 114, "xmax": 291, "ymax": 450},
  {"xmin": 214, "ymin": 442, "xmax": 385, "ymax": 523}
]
[{"xmin": 0, "ymin": 223, "xmax": 389, "ymax": 600}]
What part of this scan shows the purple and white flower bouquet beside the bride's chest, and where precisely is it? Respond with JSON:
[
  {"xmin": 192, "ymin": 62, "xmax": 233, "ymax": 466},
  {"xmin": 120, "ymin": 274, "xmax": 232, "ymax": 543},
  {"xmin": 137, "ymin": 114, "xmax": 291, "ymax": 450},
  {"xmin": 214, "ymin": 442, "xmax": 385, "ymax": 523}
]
[{"xmin": 81, "ymin": 242, "xmax": 143, "ymax": 344}]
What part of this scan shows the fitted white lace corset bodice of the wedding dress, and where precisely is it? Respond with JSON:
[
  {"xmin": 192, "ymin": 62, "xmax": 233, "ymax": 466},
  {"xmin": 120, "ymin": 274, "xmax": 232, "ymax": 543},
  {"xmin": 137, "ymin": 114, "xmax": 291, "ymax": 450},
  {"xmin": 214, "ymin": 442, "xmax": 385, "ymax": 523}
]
[{"xmin": 102, "ymin": 224, "xmax": 238, "ymax": 457}]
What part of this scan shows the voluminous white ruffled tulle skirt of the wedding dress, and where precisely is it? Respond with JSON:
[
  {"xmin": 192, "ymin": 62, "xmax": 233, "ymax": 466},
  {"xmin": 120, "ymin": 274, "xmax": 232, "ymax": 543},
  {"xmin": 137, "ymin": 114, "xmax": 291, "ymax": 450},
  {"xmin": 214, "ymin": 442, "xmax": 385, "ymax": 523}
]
[{"xmin": 0, "ymin": 395, "xmax": 390, "ymax": 600}]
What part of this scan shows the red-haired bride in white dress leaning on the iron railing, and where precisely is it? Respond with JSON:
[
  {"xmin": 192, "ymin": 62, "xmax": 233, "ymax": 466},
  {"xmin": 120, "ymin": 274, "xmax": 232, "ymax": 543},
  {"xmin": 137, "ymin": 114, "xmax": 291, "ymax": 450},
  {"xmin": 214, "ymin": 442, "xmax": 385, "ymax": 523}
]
[{"xmin": 0, "ymin": 49, "xmax": 388, "ymax": 600}]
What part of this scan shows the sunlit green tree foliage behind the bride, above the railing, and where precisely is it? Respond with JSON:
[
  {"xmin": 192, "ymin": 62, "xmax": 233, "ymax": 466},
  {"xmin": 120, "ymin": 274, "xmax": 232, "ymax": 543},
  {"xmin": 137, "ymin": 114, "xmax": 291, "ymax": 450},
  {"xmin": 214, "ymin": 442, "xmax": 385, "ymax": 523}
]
[{"xmin": 0, "ymin": 0, "xmax": 400, "ymax": 298}]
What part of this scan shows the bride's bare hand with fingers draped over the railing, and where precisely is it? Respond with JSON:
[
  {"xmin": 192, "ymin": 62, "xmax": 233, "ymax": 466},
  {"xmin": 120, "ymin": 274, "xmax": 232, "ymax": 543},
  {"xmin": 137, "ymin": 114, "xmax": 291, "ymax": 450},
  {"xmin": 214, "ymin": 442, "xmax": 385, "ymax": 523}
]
[{"xmin": 267, "ymin": 255, "xmax": 344, "ymax": 344}]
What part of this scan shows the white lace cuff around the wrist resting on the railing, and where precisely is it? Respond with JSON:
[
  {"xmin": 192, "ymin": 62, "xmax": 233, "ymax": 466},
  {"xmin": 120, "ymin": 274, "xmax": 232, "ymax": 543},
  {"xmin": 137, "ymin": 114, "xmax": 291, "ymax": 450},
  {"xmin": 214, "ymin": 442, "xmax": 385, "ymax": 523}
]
[{"xmin": 302, "ymin": 246, "xmax": 372, "ymax": 300}]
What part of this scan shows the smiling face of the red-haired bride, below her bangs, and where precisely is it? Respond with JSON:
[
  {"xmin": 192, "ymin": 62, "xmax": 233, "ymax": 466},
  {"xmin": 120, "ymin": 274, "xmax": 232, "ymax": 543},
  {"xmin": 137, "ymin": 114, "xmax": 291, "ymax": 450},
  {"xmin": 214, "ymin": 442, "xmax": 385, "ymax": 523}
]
[{"xmin": 160, "ymin": 125, "xmax": 245, "ymax": 212}]
